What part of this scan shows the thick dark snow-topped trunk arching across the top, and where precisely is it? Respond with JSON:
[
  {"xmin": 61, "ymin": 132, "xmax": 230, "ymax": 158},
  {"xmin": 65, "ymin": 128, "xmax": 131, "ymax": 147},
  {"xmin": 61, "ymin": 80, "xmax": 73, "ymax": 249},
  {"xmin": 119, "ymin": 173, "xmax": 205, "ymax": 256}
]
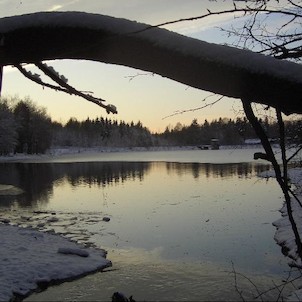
[{"xmin": 0, "ymin": 12, "xmax": 302, "ymax": 114}]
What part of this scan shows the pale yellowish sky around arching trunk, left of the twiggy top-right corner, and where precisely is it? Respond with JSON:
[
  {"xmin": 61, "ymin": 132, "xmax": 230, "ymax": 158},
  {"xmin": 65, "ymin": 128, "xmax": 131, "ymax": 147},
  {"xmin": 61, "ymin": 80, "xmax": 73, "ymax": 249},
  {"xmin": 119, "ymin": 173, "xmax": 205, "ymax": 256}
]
[{"xmin": 0, "ymin": 0, "xmax": 245, "ymax": 131}]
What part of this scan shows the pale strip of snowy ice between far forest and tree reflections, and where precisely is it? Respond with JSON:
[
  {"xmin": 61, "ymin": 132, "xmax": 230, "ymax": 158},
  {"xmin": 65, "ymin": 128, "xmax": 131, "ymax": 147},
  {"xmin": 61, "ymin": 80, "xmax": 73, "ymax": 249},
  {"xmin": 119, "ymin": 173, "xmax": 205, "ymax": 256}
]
[{"xmin": 0, "ymin": 145, "xmax": 280, "ymax": 165}]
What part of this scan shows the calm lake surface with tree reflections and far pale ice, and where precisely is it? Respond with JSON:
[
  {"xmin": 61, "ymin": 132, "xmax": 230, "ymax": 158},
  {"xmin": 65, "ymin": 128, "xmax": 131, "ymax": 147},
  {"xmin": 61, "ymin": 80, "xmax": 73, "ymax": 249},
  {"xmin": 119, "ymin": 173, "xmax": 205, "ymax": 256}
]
[{"xmin": 0, "ymin": 150, "xmax": 298, "ymax": 301}]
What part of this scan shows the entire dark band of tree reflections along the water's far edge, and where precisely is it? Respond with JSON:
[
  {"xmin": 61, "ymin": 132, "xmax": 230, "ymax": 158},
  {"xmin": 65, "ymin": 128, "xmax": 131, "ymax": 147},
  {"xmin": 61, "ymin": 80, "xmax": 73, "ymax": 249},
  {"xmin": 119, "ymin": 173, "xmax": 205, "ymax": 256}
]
[{"xmin": 0, "ymin": 162, "xmax": 269, "ymax": 207}]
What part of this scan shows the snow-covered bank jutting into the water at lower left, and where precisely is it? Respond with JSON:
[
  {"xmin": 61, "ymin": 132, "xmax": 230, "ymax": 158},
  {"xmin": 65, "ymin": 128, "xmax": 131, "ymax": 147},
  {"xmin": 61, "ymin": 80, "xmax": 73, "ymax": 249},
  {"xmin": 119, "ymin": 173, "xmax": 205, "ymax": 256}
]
[{"xmin": 0, "ymin": 223, "xmax": 111, "ymax": 301}]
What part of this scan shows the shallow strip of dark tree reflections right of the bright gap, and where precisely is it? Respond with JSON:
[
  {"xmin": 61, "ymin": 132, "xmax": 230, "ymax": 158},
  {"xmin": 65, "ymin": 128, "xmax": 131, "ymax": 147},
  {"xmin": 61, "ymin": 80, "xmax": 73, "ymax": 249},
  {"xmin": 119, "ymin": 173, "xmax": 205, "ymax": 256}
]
[{"xmin": 166, "ymin": 163, "xmax": 271, "ymax": 178}]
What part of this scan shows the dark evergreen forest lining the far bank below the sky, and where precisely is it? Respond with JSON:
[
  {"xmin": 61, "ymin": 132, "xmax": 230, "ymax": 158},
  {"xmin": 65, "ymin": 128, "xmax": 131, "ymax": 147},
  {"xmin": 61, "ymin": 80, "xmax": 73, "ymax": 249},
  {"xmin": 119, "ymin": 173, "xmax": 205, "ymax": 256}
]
[{"xmin": 0, "ymin": 98, "xmax": 302, "ymax": 155}]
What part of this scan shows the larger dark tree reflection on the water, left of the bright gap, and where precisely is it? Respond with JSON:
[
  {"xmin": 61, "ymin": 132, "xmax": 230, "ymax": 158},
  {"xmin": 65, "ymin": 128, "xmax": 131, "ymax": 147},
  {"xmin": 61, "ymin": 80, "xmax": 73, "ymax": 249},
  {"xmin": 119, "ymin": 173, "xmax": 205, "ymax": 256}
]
[{"xmin": 0, "ymin": 162, "xmax": 150, "ymax": 207}]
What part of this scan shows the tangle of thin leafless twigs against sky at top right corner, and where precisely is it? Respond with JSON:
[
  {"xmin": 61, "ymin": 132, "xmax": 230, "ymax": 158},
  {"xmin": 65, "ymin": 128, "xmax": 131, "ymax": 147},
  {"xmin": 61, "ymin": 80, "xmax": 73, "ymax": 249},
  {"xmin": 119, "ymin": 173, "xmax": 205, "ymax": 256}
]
[{"xmin": 156, "ymin": 0, "xmax": 302, "ymax": 61}]
